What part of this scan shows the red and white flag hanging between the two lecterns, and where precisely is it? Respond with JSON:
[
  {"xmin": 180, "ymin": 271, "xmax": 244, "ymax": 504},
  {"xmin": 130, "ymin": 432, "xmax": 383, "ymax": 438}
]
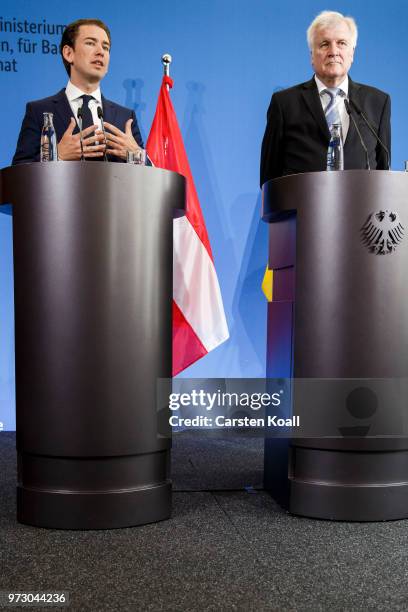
[{"xmin": 146, "ymin": 76, "xmax": 229, "ymax": 376}]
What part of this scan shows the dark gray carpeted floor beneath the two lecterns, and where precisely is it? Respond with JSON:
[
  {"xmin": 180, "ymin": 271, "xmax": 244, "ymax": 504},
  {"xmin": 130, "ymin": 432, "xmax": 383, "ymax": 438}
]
[{"xmin": 0, "ymin": 433, "xmax": 408, "ymax": 612}]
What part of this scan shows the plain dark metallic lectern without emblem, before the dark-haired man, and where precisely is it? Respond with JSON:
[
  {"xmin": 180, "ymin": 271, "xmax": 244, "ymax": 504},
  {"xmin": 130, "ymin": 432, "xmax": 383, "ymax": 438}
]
[{"xmin": 0, "ymin": 162, "xmax": 185, "ymax": 529}]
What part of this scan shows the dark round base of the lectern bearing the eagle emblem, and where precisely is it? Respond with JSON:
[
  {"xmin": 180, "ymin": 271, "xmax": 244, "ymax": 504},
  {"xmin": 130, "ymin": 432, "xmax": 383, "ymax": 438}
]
[{"xmin": 265, "ymin": 439, "xmax": 408, "ymax": 522}]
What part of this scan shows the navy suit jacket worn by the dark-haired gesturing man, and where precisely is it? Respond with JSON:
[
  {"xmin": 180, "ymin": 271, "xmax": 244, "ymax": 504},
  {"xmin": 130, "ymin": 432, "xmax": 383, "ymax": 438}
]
[{"xmin": 12, "ymin": 89, "xmax": 143, "ymax": 165}]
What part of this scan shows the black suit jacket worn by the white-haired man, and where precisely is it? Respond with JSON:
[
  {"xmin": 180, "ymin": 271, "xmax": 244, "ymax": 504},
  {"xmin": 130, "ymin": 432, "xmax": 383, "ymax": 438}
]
[{"xmin": 261, "ymin": 77, "xmax": 391, "ymax": 186}]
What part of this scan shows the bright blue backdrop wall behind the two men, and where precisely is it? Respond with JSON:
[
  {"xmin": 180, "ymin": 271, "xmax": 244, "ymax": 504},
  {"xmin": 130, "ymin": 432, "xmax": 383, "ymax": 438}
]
[{"xmin": 0, "ymin": 0, "xmax": 408, "ymax": 429}]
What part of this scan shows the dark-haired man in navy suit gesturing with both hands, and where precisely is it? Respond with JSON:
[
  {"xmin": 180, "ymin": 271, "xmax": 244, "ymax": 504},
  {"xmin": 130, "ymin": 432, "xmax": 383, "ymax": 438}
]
[{"xmin": 12, "ymin": 19, "xmax": 143, "ymax": 164}]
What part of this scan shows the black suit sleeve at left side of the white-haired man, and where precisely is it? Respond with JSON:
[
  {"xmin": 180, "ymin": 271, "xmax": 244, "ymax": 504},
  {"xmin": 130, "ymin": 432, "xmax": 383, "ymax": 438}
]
[{"xmin": 260, "ymin": 94, "xmax": 283, "ymax": 187}]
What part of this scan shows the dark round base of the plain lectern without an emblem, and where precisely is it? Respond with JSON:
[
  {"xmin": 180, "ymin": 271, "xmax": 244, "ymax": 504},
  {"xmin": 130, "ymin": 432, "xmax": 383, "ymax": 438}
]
[{"xmin": 17, "ymin": 450, "xmax": 172, "ymax": 529}]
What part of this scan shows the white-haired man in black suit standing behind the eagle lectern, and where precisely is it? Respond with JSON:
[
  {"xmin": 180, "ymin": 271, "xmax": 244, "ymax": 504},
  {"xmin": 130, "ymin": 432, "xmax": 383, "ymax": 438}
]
[{"xmin": 260, "ymin": 11, "xmax": 391, "ymax": 186}]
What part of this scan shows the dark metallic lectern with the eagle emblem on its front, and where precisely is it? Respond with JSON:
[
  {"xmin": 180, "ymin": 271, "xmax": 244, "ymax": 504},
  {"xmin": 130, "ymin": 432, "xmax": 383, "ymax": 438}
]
[{"xmin": 263, "ymin": 170, "xmax": 408, "ymax": 521}]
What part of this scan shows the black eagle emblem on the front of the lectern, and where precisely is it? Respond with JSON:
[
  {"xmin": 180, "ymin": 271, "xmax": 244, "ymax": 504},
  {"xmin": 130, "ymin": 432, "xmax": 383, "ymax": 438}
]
[{"xmin": 361, "ymin": 210, "xmax": 404, "ymax": 255}]
